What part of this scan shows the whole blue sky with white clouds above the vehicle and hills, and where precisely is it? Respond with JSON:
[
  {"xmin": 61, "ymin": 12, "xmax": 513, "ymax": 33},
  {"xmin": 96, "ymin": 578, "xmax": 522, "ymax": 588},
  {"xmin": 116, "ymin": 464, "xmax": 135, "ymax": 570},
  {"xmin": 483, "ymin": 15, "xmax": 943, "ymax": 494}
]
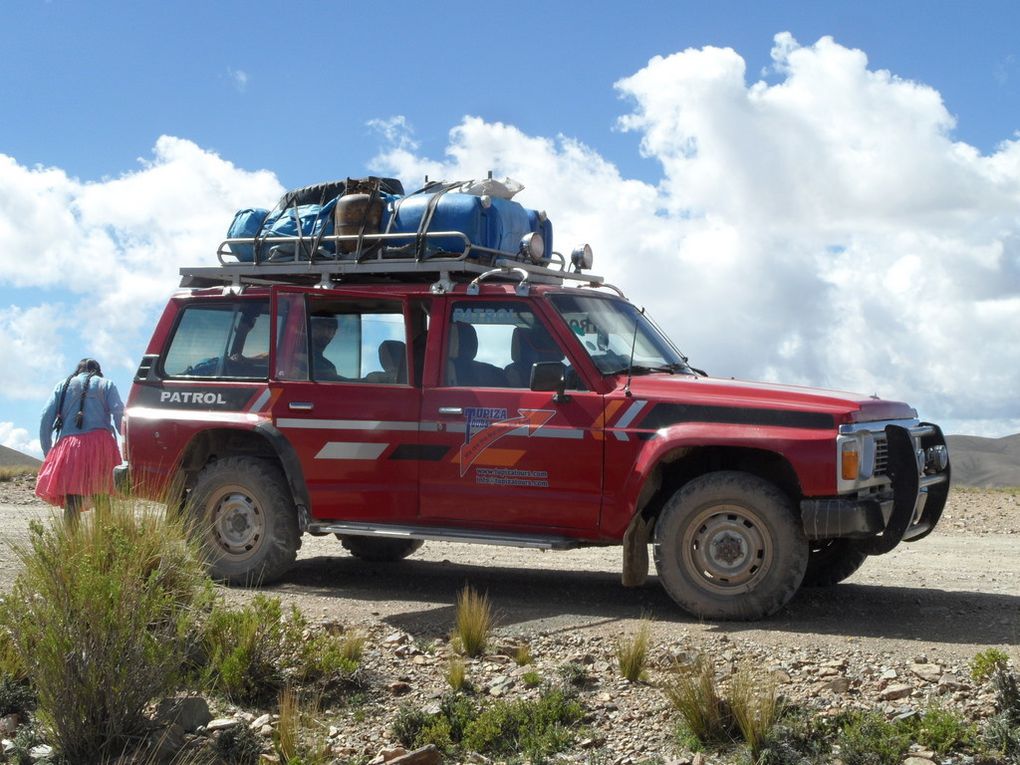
[{"xmin": 0, "ymin": 0, "xmax": 1020, "ymax": 451}]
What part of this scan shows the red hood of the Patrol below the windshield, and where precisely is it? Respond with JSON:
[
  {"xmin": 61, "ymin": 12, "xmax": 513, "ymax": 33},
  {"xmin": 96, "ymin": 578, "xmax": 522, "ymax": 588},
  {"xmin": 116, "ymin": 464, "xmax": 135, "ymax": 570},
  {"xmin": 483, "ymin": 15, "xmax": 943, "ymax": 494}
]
[{"xmin": 620, "ymin": 374, "xmax": 917, "ymax": 425}]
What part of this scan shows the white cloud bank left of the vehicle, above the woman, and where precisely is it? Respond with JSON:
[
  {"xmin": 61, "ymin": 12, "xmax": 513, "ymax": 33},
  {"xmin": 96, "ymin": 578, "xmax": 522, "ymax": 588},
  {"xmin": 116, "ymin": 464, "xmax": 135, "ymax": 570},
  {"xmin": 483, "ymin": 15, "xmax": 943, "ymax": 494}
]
[{"xmin": 0, "ymin": 136, "xmax": 282, "ymax": 400}]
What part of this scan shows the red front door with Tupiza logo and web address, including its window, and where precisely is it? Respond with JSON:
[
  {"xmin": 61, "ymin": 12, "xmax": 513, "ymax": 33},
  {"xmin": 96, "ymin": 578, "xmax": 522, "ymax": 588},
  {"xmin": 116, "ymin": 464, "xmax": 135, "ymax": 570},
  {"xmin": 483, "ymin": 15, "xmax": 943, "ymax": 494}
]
[{"xmin": 420, "ymin": 297, "xmax": 603, "ymax": 531}]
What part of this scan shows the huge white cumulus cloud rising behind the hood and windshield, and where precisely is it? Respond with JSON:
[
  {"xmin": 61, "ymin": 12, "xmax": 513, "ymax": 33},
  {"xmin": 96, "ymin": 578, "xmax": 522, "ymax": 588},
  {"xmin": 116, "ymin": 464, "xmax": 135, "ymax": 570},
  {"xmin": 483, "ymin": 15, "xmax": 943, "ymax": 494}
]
[{"xmin": 376, "ymin": 34, "xmax": 1020, "ymax": 435}]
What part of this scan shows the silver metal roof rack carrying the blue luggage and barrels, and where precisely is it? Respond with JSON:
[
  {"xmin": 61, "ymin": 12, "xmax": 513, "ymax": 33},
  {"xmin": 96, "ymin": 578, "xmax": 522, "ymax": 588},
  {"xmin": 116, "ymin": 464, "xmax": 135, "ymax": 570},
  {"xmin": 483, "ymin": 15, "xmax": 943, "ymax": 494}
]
[{"xmin": 181, "ymin": 232, "xmax": 622, "ymax": 295}]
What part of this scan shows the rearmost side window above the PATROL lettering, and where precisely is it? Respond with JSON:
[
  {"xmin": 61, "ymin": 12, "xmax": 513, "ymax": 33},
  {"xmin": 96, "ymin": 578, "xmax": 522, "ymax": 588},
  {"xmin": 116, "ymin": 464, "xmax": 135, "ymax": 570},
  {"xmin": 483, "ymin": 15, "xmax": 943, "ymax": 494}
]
[{"xmin": 163, "ymin": 300, "xmax": 269, "ymax": 379}]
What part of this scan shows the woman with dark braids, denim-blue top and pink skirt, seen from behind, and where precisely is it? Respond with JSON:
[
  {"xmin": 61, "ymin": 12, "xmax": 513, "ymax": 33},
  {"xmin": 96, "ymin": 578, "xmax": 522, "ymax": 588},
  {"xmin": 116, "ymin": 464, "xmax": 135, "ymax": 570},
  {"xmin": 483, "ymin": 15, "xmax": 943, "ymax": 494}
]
[{"xmin": 36, "ymin": 359, "xmax": 124, "ymax": 522}]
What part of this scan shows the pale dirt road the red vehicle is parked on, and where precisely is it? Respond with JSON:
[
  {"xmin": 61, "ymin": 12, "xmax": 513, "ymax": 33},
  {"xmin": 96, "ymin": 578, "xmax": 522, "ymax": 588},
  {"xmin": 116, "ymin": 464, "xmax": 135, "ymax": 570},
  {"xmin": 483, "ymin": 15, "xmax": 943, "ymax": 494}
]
[{"xmin": 0, "ymin": 486, "xmax": 1020, "ymax": 661}]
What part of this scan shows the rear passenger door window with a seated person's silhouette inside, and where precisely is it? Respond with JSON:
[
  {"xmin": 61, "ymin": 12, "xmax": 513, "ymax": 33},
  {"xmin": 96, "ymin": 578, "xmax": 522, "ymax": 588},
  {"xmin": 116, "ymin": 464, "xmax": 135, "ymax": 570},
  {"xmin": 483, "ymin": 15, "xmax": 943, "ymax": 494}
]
[{"xmin": 308, "ymin": 299, "xmax": 407, "ymax": 385}]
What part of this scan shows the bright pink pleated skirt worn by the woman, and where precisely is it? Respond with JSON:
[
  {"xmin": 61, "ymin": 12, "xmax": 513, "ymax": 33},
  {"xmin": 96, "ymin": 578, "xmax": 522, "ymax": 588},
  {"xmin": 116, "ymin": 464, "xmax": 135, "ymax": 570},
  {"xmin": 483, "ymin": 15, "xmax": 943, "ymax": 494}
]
[{"xmin": 36, "ymin": 429, "xmax": 120, "ymax": 507}]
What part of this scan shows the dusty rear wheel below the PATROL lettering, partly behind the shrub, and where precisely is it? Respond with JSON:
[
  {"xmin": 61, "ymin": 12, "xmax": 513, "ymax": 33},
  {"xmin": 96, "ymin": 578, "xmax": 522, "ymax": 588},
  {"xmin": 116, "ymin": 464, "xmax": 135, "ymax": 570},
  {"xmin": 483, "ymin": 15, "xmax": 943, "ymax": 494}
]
[{"xmin": 188, "ymin": 457, "xmax": 301, "ymax": 585}]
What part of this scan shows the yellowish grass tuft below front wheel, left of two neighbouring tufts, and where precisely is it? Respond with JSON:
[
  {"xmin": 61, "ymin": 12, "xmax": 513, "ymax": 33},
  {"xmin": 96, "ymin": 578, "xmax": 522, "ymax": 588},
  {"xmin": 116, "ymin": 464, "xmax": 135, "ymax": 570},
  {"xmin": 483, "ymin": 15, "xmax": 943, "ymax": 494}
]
[{"xmin": 662, "ymin": 655, "xmax": 734, "ymax": 745}]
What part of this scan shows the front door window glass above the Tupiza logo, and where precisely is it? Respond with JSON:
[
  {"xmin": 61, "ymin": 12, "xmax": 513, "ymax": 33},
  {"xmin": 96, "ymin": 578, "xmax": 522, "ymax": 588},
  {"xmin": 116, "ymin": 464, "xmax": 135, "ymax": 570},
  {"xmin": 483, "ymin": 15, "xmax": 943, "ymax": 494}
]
[{"xmin": 443, "ymin": 301, "xmax": 571, "ymax": 388}]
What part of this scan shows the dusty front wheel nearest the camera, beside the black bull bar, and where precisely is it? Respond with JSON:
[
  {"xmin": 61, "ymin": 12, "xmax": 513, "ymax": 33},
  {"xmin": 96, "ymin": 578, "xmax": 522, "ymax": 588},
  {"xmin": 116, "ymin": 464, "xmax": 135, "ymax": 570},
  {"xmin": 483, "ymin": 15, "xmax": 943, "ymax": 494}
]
[{"xmin": 654, "ymin": 471, "xmax": 808, "ymax": 619}]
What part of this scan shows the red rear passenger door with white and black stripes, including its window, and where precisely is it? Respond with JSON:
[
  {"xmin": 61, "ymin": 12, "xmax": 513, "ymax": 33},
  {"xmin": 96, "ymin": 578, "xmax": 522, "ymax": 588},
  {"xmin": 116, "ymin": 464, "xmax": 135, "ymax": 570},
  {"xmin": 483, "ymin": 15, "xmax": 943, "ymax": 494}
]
[{"xmin": 271, "ymin": 289, "xmax": 421, "ymax": 522}]
